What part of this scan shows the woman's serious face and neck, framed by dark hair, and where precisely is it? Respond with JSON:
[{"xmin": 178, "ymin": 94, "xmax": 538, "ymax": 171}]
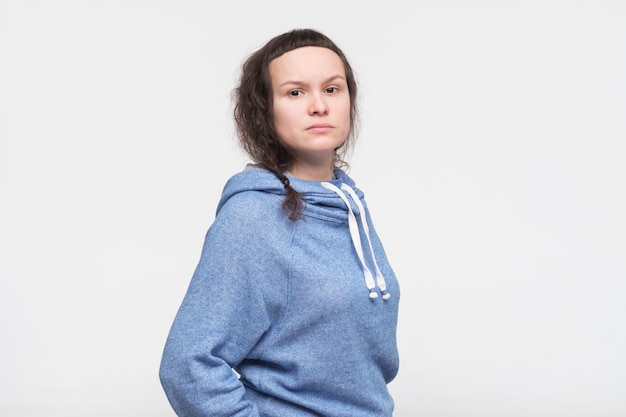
[{"xmin": 269, "ymin": 46, "xmax": 351, "ymax": 169}]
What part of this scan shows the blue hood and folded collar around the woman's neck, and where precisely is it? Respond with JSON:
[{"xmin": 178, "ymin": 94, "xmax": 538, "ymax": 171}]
[{"xmin": 217, "ymin": 164, "xmax": 363, "ymax": 221}]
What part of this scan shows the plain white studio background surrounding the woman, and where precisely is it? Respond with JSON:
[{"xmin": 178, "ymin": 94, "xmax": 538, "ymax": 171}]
[{"xmin": 0, "ymin": 0, "xmax": 626, "ymax": 417}]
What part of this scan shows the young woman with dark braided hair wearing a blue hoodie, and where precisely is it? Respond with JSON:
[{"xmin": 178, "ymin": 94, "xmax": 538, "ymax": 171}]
[{"xmin": 160, "ymin": 29, "xmax": 399, "ymax": 417}]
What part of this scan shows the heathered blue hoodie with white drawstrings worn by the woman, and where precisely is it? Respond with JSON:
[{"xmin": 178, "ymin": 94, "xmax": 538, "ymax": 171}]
[{"xmin": 160, "ymin": 166, "xmax": 400, "ymax": 417}]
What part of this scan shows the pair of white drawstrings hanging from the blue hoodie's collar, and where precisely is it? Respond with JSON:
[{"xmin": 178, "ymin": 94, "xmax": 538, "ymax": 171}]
[{"xmin": 321, "ymin": 182, "xmax": 391, "ymax": 300}]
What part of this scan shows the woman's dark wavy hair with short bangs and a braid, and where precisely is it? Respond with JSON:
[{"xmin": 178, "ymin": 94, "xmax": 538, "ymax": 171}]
[{"xmin": 233, "ymin": 29, "xmax": 358, "ymax": 220}]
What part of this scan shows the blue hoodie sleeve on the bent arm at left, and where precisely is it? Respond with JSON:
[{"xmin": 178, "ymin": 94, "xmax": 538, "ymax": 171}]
[{"xmin": 159, "ymin": 198, "xmax": 281, "ymax": 417}]
